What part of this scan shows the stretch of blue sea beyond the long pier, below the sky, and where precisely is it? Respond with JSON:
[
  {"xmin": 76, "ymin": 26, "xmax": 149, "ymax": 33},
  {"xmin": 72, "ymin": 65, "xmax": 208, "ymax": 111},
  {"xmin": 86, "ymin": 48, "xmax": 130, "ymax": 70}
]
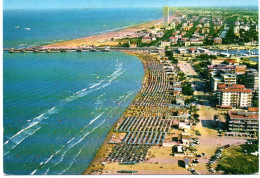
[{"xmin": 3, "ymin": 8, "xmax": 162, "ymax": 48}]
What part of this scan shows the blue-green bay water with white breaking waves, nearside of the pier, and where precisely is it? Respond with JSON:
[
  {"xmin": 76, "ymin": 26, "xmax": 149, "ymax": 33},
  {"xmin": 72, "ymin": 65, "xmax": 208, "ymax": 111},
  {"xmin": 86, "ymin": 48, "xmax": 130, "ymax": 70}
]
[{"xmin": 4, "ymin": 52, "xmax": 143, "ymax": 174}]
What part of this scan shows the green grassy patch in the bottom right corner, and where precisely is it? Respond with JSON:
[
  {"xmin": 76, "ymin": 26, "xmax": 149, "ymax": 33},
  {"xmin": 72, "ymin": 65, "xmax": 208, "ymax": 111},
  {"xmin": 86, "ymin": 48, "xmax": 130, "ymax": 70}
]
[{"xmin": 217, "ymin": 144, "xmax": 259, "ymax": 174}]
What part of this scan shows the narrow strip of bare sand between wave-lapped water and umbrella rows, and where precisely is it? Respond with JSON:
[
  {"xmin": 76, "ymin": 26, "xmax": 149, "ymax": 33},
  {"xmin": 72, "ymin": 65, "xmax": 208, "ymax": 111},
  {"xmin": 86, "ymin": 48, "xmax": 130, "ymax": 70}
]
[{"xmin": 81, "ymin": 50, "xmax": 148, "ymax": 175}]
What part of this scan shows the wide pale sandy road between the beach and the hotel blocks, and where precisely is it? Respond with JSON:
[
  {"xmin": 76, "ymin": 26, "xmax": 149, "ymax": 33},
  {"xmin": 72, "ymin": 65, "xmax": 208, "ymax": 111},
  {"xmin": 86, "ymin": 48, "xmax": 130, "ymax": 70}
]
[{"xmin": 178, "ymin": 61, "xmax": 247, "ymax": 174}]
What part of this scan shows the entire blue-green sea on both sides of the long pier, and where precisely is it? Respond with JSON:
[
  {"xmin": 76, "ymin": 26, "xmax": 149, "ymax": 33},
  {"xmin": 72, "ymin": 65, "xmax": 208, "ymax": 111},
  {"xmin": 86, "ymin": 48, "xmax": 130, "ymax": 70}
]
[{"xmin": 3, "ymin": 9, "xmax": 162, "ymax": 175}]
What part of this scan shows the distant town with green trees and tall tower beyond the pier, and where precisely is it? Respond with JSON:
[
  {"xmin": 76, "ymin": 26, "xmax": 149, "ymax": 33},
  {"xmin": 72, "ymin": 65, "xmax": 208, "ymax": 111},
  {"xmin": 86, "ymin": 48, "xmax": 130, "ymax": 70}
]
[{"xmin": 117, "ymin": 6, "xmax": 258, "ymax": 47}]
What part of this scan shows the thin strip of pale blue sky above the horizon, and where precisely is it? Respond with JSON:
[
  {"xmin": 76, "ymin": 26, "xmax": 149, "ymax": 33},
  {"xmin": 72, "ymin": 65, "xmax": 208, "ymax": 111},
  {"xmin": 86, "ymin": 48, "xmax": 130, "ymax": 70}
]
[{"xmin": 3, "ymin": 0, "xmax": 258, "ymax": 9}]
